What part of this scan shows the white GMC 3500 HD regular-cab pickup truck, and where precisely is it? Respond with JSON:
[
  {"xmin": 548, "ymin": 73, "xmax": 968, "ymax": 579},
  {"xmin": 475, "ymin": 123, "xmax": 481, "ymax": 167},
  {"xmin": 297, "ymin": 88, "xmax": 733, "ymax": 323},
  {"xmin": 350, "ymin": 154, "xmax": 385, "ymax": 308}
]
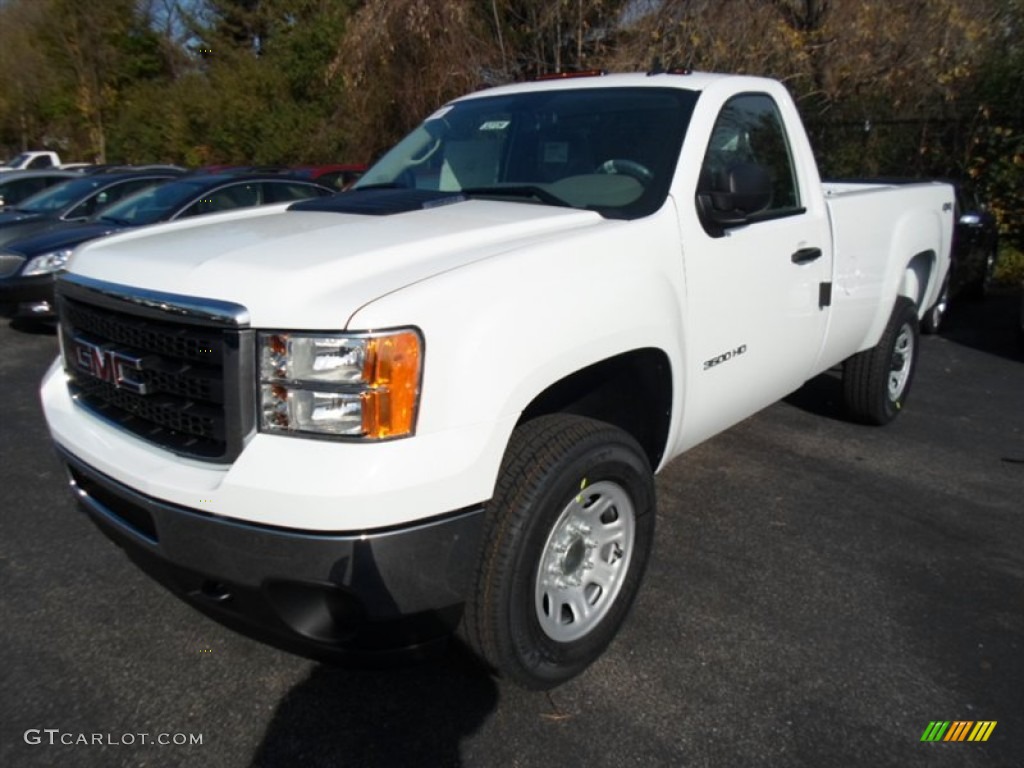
[{"xmin": 42, "ymin": 72, "xmax": 953, "ymax": 688}]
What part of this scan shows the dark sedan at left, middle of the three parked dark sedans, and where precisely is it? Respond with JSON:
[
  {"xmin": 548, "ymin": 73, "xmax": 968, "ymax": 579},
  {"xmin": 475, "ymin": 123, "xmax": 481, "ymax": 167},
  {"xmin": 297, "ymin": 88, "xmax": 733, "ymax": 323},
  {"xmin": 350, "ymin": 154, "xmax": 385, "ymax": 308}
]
[{"xmin": 0, "ymin": 170, "xmax": 181, "ymax": 246}]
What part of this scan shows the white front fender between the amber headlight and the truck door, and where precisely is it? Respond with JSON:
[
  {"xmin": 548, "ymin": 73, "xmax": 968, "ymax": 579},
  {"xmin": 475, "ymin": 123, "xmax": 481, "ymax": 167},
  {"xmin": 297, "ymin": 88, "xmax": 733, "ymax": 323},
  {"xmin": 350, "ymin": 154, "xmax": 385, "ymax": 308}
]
[{"xmin": 349, "ymin": 207, "xmax": 684, "ymax": 487}]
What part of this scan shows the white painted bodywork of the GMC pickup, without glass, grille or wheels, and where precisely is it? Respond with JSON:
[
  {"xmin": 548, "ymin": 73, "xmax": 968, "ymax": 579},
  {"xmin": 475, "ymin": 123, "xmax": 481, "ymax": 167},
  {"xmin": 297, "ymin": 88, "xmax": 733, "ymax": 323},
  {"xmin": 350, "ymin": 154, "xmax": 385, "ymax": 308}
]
[{"xmin": 42, "ymin": 75, "xmax": 952, "ymax": 530}]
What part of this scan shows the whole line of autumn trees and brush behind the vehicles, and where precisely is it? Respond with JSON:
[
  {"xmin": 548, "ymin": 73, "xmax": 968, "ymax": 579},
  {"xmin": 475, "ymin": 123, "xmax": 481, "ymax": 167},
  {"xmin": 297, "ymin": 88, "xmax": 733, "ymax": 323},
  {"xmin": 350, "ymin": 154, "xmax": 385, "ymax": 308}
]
[{"xmin": 0, "ymin": 0, "xmax": 1024, "ymax": 250}]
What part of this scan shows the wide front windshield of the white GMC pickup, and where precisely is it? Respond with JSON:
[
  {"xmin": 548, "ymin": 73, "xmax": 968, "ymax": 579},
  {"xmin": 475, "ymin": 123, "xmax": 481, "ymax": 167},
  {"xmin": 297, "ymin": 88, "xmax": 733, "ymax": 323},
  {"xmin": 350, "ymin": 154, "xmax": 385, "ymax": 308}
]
[{"xmin": 353, "ymin": 88, "xmax": 696, "ymax": 218}]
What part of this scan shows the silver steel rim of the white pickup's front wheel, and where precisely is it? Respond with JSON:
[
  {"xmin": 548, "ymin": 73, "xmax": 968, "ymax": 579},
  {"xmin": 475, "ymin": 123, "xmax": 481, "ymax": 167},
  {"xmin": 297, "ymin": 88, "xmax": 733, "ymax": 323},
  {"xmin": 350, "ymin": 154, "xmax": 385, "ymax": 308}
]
[{"xmin": 534, "ymin": 480, "xmax": 636, "ymax": 643}]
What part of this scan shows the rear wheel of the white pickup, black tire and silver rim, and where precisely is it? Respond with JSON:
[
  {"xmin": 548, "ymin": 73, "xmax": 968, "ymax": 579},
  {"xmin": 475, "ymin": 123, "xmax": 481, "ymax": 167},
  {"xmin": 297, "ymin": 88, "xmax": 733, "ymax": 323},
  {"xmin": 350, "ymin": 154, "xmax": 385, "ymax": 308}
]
[{"xmin": 843, "ymin": 296, "xmax": 920, "ymax": 425}]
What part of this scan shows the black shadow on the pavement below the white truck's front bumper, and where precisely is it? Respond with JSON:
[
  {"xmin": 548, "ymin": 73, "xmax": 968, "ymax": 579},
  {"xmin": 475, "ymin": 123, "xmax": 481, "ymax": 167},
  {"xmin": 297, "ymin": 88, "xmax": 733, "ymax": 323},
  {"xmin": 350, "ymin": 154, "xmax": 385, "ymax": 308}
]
[{"xmin": 251, "ymin": 644, "xmax": 498, "ymax": 768}]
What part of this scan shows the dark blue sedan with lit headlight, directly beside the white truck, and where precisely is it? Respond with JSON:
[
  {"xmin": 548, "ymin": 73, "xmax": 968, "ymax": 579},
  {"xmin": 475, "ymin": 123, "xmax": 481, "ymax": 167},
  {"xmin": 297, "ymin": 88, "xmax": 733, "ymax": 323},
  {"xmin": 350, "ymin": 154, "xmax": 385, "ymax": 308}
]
[{"xmin": 0, "ymin": 174, "xmax": 334, "ymax": 319}]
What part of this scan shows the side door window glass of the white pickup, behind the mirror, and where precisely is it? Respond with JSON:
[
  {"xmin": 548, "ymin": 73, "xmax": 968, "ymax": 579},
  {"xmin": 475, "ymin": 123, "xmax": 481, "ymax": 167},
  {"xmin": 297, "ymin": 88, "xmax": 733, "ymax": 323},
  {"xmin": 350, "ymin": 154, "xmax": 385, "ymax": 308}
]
[{"xmin": 697, "ymin": 93, "xmax": 803, "ymax": 218}]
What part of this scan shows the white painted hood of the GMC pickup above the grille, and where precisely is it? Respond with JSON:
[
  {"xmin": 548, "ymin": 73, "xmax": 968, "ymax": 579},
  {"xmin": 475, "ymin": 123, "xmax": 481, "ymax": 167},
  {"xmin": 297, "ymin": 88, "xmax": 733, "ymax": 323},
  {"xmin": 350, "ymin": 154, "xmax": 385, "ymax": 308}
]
[{"xmin": 71, "ymin": 200, "xmax": 605, "ymax": 329}]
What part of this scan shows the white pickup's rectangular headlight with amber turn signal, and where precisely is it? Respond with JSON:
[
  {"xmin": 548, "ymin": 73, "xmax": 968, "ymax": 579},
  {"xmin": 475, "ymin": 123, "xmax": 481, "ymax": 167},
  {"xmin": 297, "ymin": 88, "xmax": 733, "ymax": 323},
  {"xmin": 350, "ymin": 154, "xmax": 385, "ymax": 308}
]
[{"xmin": 257, "ymin": 330, "xmax": 423, "ymax": 439}]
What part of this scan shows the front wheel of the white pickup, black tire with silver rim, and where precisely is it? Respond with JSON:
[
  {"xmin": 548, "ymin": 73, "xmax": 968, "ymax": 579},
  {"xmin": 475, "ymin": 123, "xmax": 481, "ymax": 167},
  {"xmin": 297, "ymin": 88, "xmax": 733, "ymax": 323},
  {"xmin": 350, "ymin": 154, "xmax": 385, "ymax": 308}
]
[{"xmin": 461, "ymin": 415, "xmax": 655, "ymax": 690}]
